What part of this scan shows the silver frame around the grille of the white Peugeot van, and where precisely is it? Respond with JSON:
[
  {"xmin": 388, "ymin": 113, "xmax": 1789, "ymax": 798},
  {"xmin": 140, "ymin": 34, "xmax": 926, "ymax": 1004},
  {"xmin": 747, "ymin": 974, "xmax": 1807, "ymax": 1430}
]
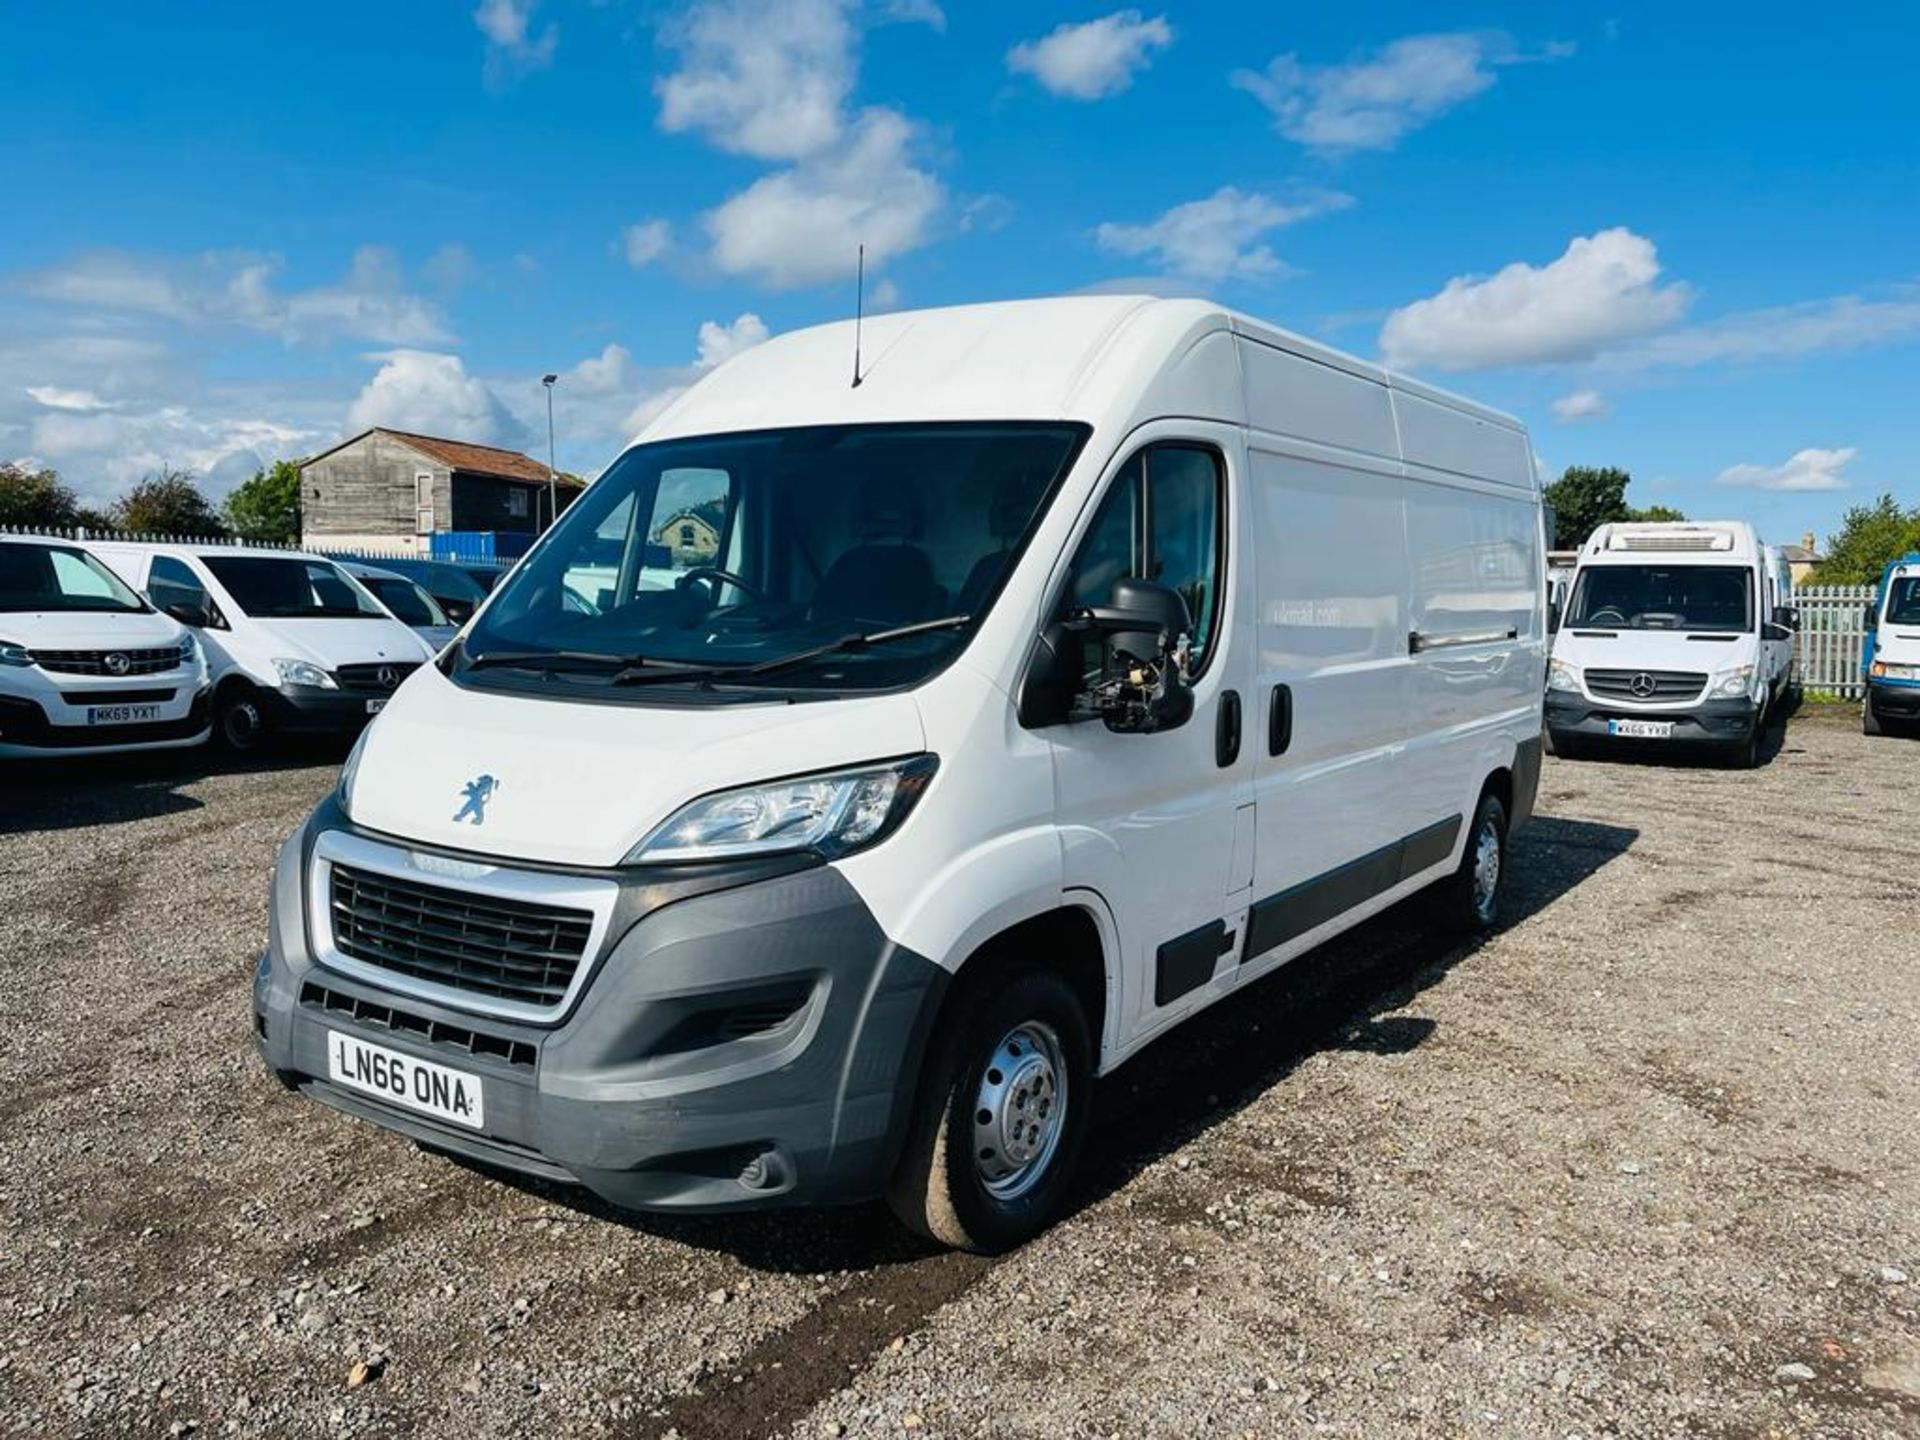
[{"xmin": 307, "ymin": 829, "xmax": 620, "ymax": 1025}]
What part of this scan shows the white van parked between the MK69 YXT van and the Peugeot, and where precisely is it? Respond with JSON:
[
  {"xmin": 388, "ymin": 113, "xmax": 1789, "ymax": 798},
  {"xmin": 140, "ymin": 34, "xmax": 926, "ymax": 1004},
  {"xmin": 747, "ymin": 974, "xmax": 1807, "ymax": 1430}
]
[{"xmin": 94, "ymin": 540, "xmax": 432, "ymax": 751}]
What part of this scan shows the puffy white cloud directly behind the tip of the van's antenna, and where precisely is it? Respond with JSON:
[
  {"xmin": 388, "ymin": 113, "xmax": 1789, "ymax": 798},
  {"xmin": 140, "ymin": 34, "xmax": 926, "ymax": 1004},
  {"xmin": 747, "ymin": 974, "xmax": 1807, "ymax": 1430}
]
[{"xmin": 703, "ymin": 108, "xmax": 947, "ymax": 290}]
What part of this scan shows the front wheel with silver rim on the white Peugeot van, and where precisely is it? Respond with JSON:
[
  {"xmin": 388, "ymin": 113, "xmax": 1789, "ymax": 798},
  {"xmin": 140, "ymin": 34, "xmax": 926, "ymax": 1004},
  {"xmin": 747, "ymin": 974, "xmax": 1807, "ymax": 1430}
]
[{"xmin": 887, "ymin": 966, "xmax": 1092, "ymax": 1254}]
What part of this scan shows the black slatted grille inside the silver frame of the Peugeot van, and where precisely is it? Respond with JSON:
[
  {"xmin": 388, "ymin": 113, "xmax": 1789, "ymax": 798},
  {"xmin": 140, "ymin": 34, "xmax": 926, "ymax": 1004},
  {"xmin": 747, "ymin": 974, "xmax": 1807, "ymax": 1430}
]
[{"xmin": 332, "ymin": 862, "xmax": 593, "ymax": 1006}]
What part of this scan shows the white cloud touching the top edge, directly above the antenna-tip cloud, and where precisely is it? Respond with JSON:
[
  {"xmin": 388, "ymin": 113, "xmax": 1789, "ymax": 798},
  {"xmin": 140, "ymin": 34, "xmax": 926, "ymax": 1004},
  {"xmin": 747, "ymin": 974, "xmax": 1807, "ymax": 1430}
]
[{"xmin": 653, "ymin": 0, "xmax": 854, "ymax": 159}]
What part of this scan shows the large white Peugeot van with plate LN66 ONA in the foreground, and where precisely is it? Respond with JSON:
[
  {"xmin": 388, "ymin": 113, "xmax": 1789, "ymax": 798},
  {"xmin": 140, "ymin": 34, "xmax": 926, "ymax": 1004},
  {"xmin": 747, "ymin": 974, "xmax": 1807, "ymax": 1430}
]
[{"xmin": 253, "ymin": 296, "xmax": 1548, "ymax": 1248}]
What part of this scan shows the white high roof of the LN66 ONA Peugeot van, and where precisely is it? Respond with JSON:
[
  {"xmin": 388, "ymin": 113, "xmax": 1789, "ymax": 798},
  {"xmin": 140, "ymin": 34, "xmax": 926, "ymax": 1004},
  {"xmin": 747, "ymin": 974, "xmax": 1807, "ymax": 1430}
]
[{"xmin": 639, "ymin": 296, "xmax": 1532, "ymax": 484}]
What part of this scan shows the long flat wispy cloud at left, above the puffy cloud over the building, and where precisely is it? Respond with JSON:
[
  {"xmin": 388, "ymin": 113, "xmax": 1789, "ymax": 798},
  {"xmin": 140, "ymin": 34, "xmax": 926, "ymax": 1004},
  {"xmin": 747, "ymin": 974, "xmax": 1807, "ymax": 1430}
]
[{"xmin": 21, "ymin": 246, "xmax": 447, "ymax": 346}]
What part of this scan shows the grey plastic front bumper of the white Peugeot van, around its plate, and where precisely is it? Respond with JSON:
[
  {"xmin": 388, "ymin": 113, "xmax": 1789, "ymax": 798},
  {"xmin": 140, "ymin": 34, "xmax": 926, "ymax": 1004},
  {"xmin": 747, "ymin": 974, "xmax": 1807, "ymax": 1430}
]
[{"xmin": 253, "ymin": 803, "xmax": 948, "ymax": 1212}]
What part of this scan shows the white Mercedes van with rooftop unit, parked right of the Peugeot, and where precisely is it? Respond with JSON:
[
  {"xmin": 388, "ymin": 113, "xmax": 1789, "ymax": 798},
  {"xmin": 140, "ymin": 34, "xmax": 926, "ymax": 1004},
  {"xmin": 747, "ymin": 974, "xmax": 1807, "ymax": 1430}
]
[{"xmin": 1548, "ymin": 520, "xmax": 1793, "ymax": 766}]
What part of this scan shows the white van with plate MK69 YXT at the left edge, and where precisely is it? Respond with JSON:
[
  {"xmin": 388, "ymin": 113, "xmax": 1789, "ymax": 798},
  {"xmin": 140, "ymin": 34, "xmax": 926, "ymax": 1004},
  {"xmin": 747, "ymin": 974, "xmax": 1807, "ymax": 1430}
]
[{"xmin": 0, "ymin": 536, "xmax": 207, "ymax": 758}]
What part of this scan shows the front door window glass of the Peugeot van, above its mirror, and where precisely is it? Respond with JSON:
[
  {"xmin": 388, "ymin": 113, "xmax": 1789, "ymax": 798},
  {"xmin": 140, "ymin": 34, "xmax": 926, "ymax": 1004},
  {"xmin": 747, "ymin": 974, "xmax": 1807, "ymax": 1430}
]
[{"xmin": 1062, "ymin": 444, "xmax": 1225, "ymax": 670}]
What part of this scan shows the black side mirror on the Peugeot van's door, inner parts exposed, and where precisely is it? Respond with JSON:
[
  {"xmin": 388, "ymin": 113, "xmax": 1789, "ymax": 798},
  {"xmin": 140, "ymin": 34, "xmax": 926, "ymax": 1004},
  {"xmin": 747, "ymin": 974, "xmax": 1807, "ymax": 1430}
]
[{"xmin": 1020, "ymin": 578, "xmax": 1194, "ymax": 735}]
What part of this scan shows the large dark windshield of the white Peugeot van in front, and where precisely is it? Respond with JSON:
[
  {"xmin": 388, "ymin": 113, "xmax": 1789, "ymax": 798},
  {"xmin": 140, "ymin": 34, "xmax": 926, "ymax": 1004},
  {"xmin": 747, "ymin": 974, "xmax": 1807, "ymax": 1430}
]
[{"xmin": 455, "ymin": 422, "xmax": 1087, "ymax": 693}]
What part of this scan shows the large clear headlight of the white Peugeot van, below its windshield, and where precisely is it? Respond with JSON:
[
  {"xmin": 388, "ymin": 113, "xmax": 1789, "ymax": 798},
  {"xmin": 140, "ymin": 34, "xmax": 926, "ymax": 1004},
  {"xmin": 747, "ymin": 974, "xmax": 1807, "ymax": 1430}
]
[{"xmin": 626, "ymin": 755, "xmax": 937, "ymax": 864}]
